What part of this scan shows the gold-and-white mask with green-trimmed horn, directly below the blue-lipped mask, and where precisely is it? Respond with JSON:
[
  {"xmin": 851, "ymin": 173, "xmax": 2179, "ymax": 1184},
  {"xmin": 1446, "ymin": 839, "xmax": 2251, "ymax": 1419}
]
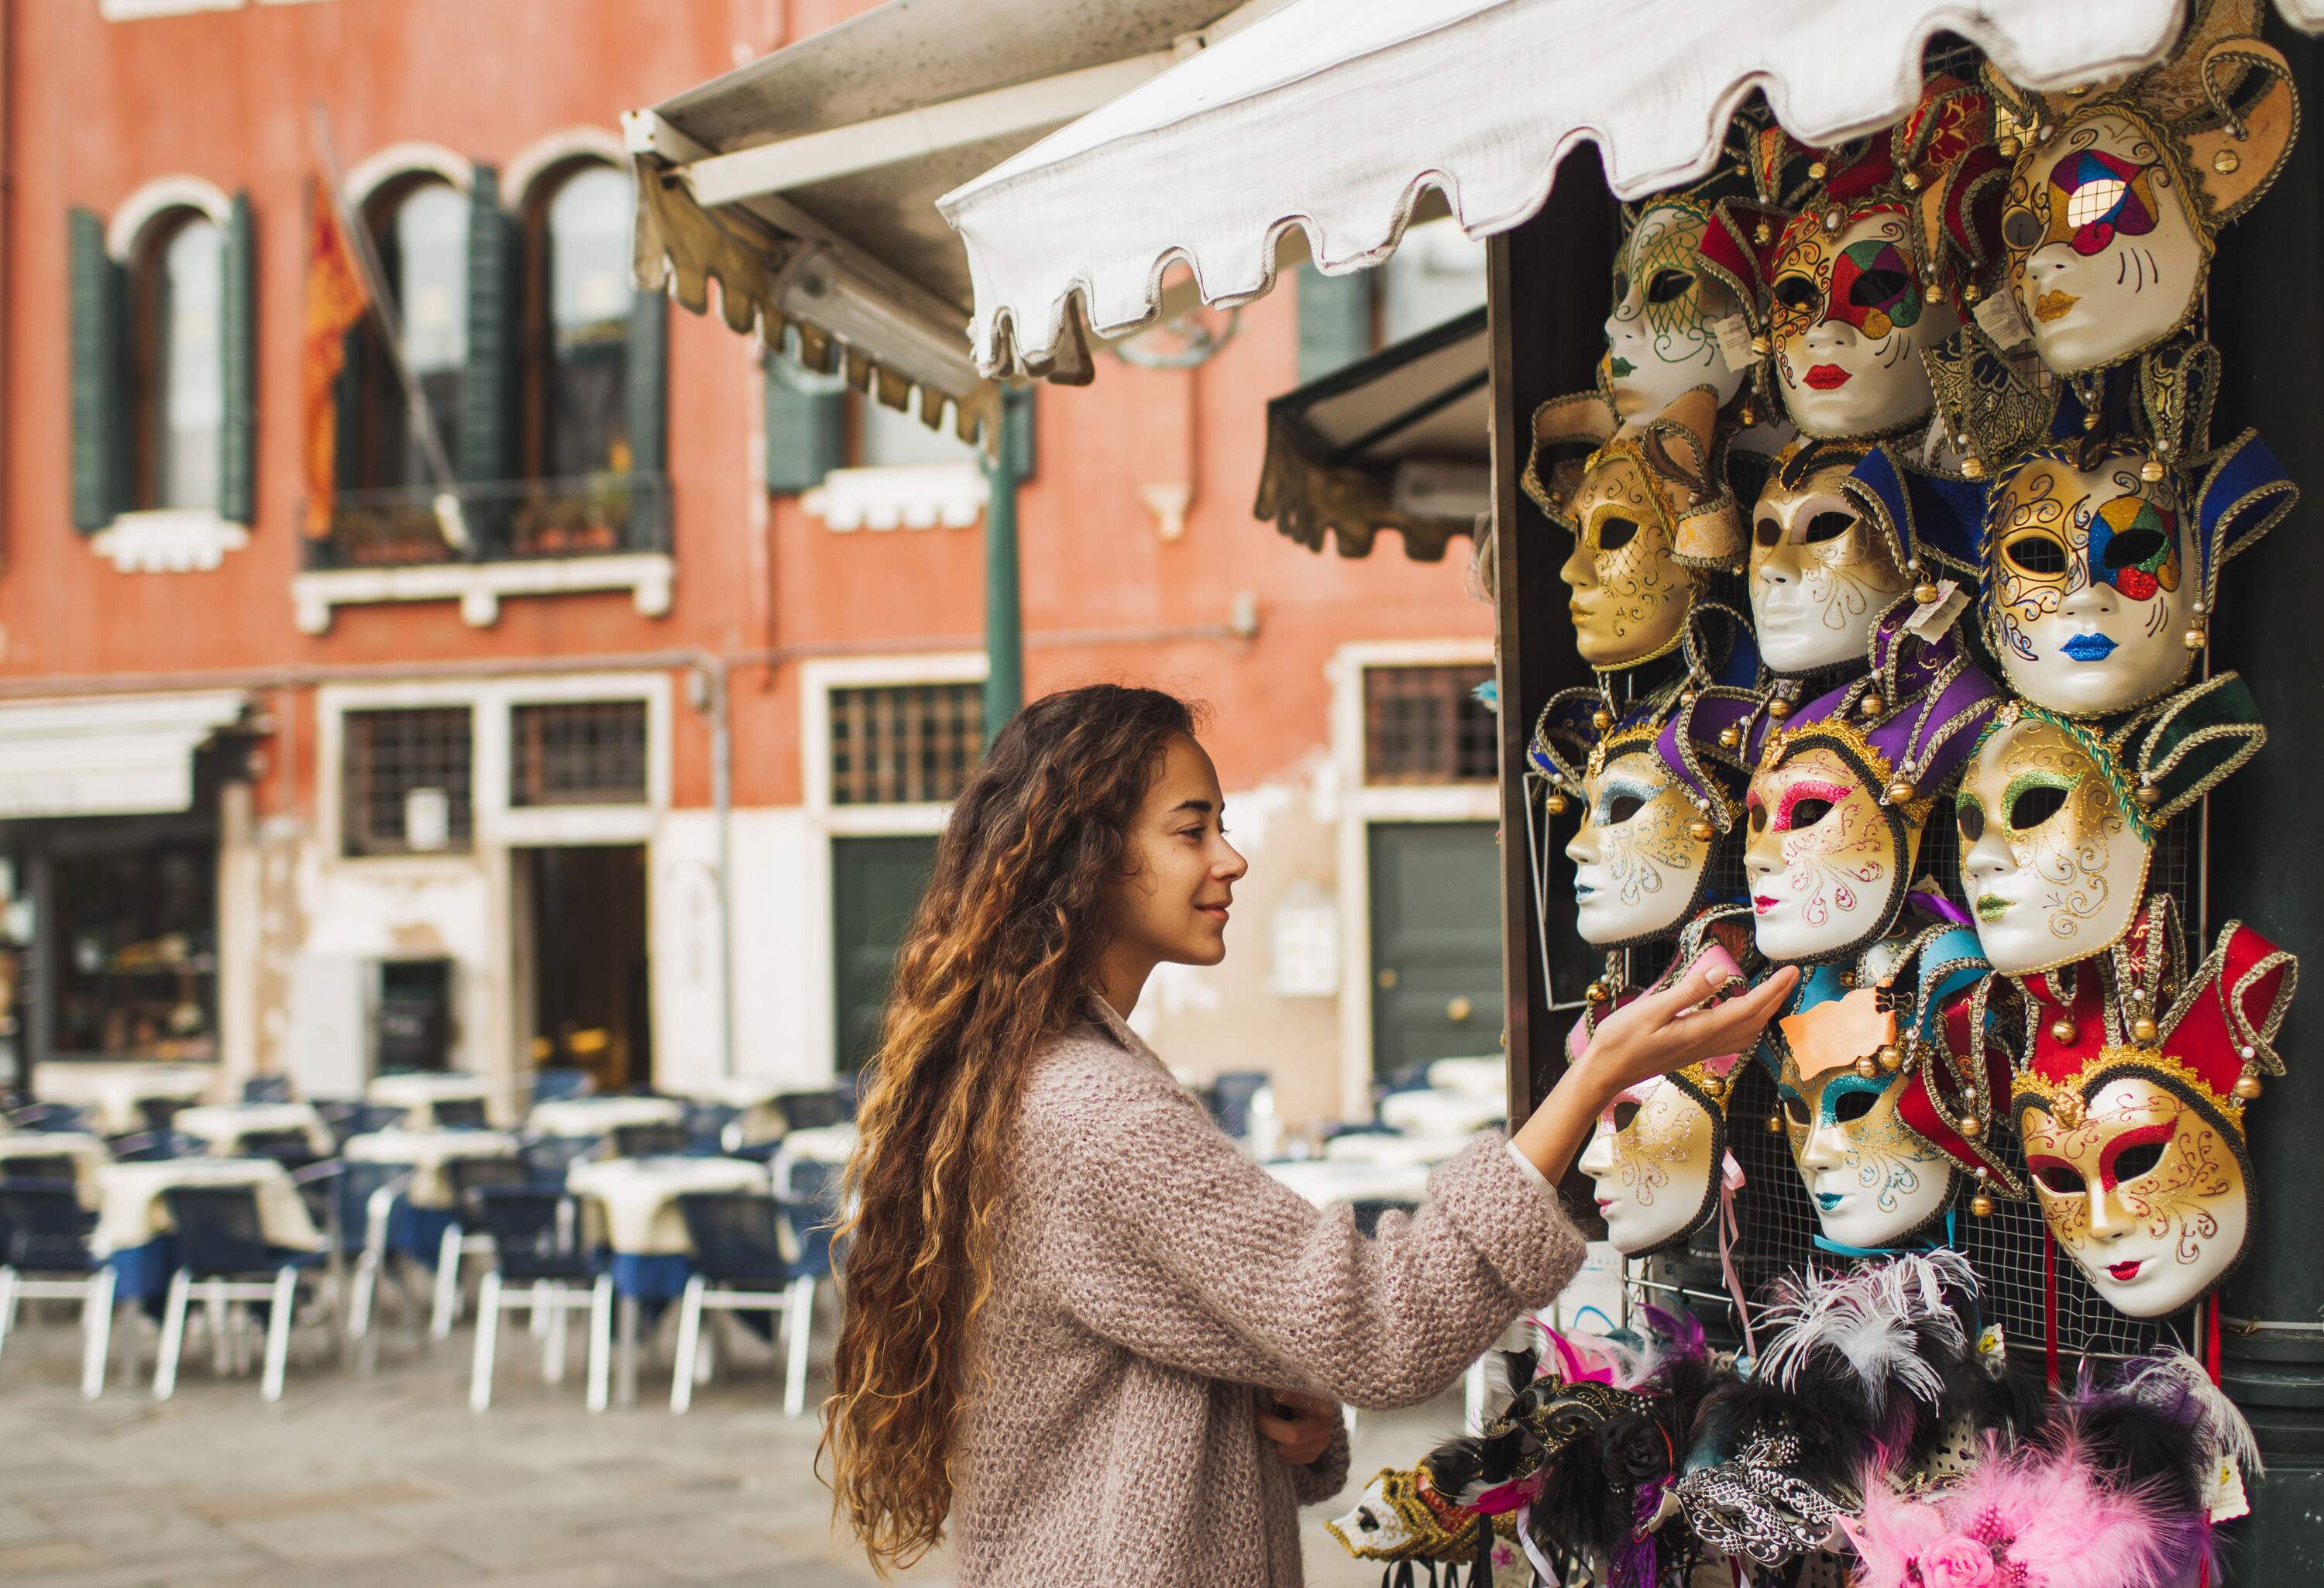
[{"xmin": 1952, "ymin": 672, "xmax": 2266, "ymax": 977}]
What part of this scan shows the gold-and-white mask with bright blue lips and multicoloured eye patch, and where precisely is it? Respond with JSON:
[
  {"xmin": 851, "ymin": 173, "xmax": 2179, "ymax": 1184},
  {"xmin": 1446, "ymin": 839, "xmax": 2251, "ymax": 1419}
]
[{"xmin": 1985, "ymin": 432, "xmax": 2296, "ymax": 716}]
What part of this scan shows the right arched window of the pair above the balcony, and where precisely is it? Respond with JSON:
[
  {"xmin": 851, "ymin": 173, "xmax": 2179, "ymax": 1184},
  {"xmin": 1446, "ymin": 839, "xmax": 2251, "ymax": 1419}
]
[{"xmin": 523, "ymin": 160, "xmax": 639, "ymax": 479}]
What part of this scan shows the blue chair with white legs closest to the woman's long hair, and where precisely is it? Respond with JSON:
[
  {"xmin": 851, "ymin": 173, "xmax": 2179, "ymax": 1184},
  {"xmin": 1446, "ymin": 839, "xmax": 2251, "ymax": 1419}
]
[{"xmin": 669, "ymin": 1191, "xmax": 830, "ymax": 1416}]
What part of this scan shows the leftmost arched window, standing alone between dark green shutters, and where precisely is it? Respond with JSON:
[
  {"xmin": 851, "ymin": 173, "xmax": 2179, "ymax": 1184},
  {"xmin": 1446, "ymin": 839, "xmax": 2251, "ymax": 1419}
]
[{"xmin": 130, "ymin": 209, "xmax": 225, "ymax": 511}]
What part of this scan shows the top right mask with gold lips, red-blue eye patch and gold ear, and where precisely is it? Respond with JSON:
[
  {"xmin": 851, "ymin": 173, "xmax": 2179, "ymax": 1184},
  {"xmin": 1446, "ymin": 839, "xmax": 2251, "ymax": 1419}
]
[{"xmin": 1994, "ymin": 0, "xmax": 2298, "ymax": 374}]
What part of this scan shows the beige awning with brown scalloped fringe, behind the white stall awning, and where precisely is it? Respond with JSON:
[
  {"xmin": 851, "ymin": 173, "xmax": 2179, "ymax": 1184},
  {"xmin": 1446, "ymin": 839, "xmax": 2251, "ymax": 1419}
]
[{"xmin": 623, "ymin": 0, "xmax": 1283, "ymax": 439}]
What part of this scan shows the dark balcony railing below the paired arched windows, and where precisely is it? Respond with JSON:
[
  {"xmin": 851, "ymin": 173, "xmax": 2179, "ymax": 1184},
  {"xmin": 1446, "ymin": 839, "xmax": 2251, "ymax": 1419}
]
[{"xmin": 307, "ymin": 474, "xmax": 669, "ymax": 569}]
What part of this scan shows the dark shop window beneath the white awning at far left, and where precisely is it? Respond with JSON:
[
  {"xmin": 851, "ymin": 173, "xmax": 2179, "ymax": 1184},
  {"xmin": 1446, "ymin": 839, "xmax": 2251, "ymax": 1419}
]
[{"xmin": 49, "ymin": 840, "xmax": 218, "ymax": 1060}]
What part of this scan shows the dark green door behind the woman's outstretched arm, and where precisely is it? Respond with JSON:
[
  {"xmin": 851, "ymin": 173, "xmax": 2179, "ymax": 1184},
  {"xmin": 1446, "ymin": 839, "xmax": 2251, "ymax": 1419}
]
[{"xmin": 1367, "ymin": 821, "xmax": 1501, "ymax": 1074}]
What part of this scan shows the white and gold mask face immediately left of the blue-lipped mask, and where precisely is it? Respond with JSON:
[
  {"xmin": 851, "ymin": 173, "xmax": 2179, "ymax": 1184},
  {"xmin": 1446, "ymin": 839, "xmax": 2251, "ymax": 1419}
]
[{"xmin": 1750, "ymin": 460, "xmax": 1913, "ymax": 672}]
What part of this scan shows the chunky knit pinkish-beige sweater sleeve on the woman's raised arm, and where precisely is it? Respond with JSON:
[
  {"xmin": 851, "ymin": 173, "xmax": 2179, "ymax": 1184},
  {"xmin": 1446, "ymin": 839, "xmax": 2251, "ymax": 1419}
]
[{"xmin": 1025, "ymin": 1088, "xmax": 1583, "ymax": 1409}]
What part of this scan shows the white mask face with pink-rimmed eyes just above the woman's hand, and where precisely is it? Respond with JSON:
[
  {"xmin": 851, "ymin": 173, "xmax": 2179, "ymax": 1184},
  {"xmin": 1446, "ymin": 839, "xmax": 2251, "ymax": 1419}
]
[{"xmin": 1743, "ymin": 744, "xmax": 1920, "ymax": 963}]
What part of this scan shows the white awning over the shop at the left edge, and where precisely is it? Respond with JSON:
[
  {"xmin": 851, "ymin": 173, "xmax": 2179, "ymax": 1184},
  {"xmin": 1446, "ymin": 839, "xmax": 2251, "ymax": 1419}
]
[{"xmin": 0, "ymin": 690, "xmax": 249, "ymax": 821}]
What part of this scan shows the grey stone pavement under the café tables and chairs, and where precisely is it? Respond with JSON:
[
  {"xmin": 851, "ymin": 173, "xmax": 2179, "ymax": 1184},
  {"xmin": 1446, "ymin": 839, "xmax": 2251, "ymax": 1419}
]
[{"xmin": 0, "ymin": 1304, "xmax": 1459, "ymax": 1588}]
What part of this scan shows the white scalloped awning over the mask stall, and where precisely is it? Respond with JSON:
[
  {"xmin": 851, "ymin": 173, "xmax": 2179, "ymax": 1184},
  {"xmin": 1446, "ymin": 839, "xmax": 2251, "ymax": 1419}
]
[{"xmin": 939, "ymin": 0, "xmax": 2324, "ymax": 379}]
